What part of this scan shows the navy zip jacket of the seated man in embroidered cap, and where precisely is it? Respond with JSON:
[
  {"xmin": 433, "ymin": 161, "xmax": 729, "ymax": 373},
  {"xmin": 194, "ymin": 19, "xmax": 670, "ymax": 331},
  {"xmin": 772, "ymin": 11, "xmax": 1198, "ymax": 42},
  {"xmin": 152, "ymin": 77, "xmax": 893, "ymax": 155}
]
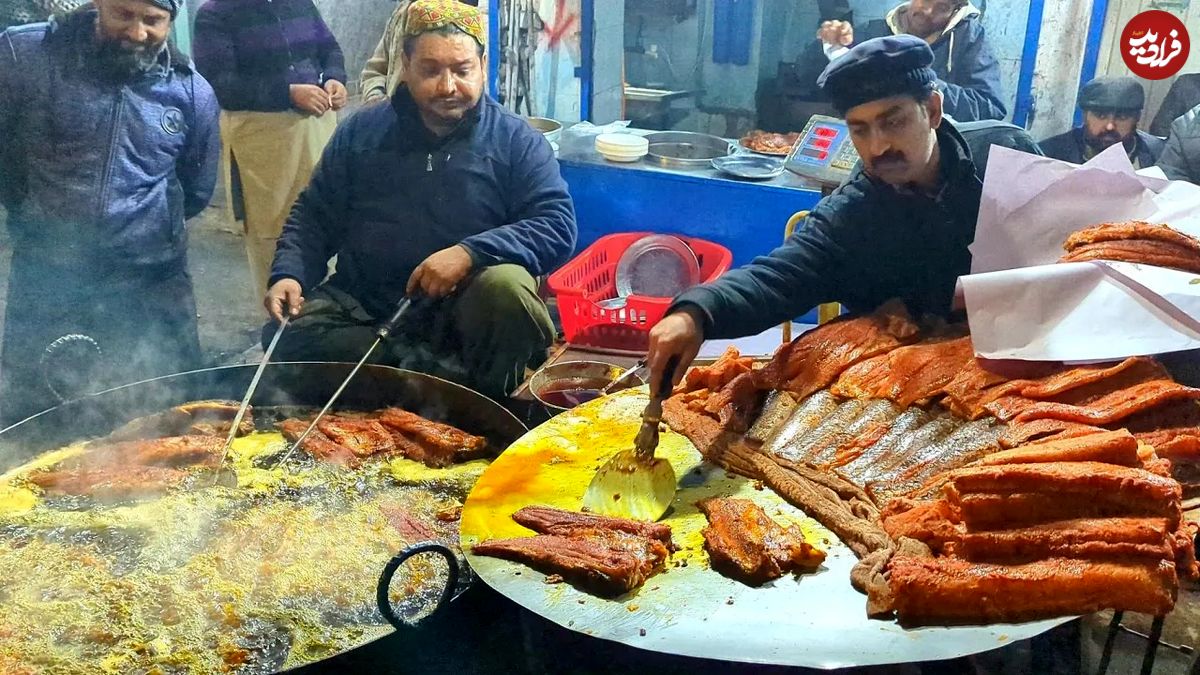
[{"xmin": 271, "ymin": 88, "xmax": 577, "ymax": 316}]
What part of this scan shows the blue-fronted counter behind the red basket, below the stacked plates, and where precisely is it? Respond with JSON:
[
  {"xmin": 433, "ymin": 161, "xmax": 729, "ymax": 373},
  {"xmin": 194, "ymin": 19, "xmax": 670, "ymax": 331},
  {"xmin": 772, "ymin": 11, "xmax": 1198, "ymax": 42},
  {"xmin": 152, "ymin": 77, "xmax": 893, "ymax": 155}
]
[{"xmin": 558, "ymin": 130, "xmax": 821, "ymax": 265}]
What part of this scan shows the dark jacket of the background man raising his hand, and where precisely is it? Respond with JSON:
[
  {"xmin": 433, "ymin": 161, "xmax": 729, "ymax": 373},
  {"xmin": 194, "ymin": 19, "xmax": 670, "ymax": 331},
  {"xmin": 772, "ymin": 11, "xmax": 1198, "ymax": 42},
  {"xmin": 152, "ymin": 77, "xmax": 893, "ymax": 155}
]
[{"xmin": 854, "ymin": 2, "xmax": 1008, "ymax": 121}]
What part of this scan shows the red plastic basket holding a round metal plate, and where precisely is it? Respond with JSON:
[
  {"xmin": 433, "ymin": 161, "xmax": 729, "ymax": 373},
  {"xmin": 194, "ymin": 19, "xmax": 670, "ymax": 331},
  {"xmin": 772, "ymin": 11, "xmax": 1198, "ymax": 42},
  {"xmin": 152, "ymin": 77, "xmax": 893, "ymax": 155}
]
[{"xmin": 548, "ymin": 232, "xmax": 733, "ymax": 353}]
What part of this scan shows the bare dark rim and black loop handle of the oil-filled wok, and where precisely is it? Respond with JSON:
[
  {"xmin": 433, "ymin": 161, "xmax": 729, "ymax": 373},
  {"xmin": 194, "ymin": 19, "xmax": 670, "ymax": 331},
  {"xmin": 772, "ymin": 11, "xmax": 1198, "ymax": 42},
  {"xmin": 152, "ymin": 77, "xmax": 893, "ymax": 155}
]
[{"xmin": 0, "ymin": 363, "xmax": 527, "ymax": 668}]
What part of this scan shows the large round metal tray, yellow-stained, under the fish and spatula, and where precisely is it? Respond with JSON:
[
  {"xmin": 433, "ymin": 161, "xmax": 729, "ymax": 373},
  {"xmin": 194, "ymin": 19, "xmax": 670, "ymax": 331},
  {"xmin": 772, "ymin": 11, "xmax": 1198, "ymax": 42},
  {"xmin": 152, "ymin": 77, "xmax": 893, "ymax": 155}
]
[{"xmin": 461, "ymin": 387, "xmax": 1069, "ymax": 668}]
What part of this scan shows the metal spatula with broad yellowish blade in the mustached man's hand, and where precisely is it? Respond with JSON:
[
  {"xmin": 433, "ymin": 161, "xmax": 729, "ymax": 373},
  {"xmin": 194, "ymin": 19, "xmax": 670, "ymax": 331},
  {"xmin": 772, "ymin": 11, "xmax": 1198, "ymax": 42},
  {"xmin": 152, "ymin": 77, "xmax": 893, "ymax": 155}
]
[{"xmin": 583, "ymin": 359, "xmax": 679, "ymax": 521}]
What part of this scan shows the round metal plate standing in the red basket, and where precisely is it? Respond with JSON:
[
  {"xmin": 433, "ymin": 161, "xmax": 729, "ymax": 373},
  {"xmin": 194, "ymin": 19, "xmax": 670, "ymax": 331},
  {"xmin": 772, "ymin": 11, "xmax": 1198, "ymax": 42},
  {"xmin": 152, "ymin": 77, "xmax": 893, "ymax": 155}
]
[{"xmin": 616, "ymin": 234, "xmax": 700, "ymax": 298}]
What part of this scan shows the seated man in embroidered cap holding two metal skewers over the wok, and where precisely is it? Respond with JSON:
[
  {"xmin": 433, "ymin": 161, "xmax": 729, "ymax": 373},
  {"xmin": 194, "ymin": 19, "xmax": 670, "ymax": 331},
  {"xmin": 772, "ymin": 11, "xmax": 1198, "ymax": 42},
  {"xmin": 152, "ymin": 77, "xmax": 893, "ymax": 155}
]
[{"xmin": 264, "ymin": 0, "xmax": 576, "ymax": 398}]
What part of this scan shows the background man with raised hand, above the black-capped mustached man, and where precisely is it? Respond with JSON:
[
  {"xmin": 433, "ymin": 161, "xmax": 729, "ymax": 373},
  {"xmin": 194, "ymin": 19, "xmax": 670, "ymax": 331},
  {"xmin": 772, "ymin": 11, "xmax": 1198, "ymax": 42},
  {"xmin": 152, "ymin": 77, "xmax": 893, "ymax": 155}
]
[{"xmin": 817, "ymin": 0, "xmax": 1007, "ymax": 123}]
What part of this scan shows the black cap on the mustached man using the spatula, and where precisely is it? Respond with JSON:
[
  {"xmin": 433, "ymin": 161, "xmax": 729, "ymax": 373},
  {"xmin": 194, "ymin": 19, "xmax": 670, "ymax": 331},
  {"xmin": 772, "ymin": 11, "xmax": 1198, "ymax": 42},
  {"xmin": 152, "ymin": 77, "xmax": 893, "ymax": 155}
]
[{"xmin": 817, "ymin": 35, "xmax": 937, "ymax": 114}]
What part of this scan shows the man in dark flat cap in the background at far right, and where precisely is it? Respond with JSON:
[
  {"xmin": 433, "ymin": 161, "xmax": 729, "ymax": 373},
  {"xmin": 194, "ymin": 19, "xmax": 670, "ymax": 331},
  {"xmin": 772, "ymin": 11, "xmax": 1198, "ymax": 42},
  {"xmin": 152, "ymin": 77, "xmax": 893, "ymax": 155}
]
[{"xmin": 1038, "ymin": 77, "xmax": 1163, "ymax": 168}]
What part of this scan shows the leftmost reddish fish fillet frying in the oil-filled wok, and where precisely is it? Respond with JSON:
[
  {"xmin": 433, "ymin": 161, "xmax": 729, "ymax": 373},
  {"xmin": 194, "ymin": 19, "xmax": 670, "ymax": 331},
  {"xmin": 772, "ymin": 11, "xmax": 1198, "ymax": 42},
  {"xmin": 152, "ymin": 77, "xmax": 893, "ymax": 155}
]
[{"xmin": 28, "ymin": 466, "xmax": 187, "ymax": 502}]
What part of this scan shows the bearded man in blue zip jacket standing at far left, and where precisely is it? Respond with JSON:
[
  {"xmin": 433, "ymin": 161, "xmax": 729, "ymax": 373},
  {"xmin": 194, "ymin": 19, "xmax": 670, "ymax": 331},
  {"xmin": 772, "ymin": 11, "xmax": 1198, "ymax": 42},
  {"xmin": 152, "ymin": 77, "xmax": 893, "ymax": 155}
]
[{"xmin": 0, "ymin": 0, "xmax": 220, "ymax": 422}]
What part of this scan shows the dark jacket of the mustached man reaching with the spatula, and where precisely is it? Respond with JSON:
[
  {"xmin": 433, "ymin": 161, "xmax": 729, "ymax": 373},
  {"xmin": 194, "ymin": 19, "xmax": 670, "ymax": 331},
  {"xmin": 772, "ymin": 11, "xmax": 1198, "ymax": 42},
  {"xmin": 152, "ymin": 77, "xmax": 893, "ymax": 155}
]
[{"xmin": 672, "ymin": 123, "xmax": 983, "ymax": 339}]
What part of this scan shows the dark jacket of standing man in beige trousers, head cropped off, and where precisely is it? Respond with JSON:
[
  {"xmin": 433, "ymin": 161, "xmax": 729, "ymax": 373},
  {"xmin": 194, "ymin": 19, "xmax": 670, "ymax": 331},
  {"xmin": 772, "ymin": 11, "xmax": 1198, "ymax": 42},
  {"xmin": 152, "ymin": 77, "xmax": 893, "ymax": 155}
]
[{"xmin": 193, "ymin": 0, "xmax": 347, "ymax": 113}]
